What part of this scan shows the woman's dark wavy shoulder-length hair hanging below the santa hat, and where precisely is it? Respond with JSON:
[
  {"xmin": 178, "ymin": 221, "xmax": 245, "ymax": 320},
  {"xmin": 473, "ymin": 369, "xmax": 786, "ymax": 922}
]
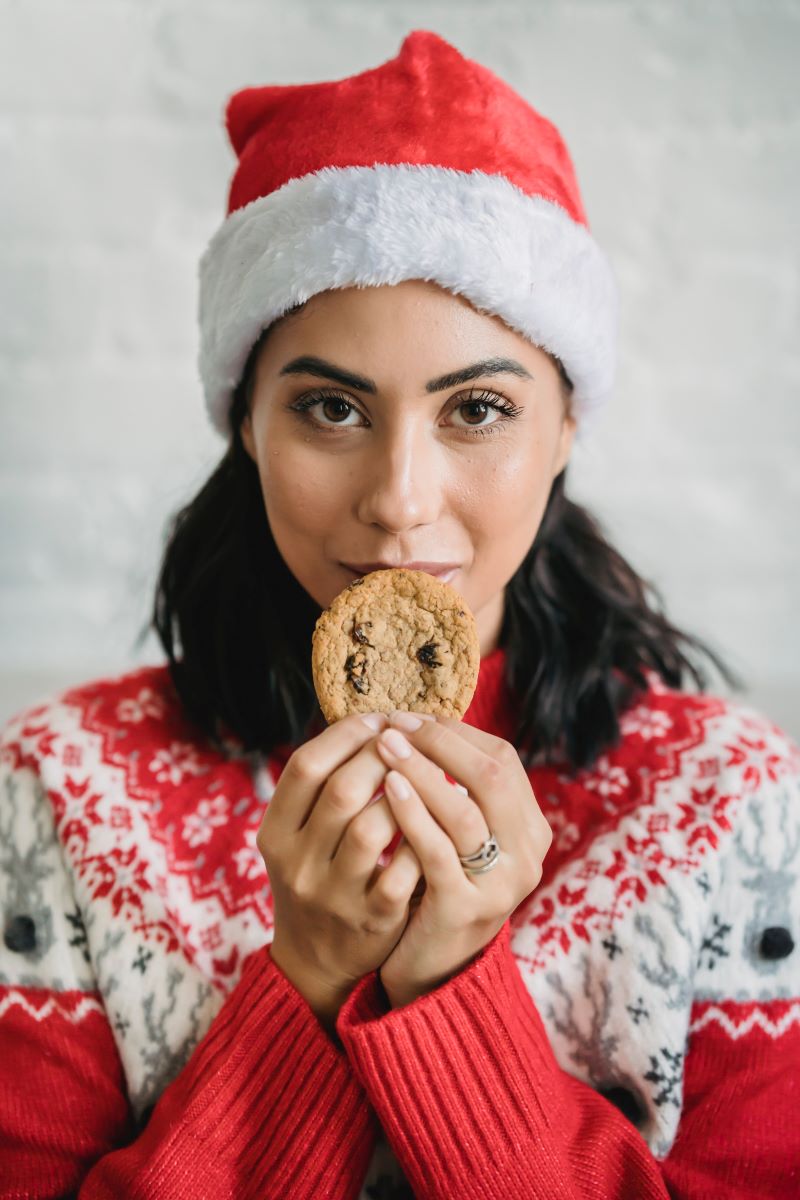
[{"xmin": 148, "ymin": 314, "xmax": 742, "ymax": 772}]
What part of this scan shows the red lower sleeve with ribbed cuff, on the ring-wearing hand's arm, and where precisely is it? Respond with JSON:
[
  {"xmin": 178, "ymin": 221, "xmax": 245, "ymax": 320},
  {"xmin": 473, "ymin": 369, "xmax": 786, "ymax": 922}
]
[{"xmin": 337, "ymin": 922, "xmax": 800, "ymax": 1200}]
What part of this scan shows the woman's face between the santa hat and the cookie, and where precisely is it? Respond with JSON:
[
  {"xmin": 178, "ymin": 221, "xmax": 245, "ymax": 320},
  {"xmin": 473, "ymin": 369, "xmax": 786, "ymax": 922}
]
[{"xmin": 242, "ymin": 280, "xmax": 575, "ymax": 656}]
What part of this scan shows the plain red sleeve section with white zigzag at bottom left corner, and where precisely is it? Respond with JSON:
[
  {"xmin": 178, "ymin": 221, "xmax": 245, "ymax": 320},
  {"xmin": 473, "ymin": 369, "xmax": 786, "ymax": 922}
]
[{"xmin": 0, "ymin": 986, "xmax": 133, "ymax": 1200}]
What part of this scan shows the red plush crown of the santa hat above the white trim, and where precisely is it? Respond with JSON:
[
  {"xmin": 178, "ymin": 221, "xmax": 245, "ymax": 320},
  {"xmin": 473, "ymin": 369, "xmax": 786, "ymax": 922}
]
[{"xmin": 225, "ymin": 30, "xmax": 588, "ymax": 226}]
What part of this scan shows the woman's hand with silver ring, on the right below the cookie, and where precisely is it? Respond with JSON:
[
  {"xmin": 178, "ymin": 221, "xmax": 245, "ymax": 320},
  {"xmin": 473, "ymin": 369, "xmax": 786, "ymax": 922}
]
[{"xmin": 377, "ymin": 714, "xmax": 553, "ymax": 1008}]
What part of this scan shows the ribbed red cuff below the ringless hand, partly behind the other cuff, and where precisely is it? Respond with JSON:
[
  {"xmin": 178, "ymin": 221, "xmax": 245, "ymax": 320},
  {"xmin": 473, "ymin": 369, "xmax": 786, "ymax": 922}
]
[{"xmin": 89, "ymin": 947, "xmax": 378, "ymax": 1200}]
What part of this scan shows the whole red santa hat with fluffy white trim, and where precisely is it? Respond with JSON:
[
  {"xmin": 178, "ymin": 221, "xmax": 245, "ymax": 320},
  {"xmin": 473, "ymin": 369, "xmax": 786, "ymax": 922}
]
[{"xmin": 199, "ymin": 30, "xmax": 618, "ymax": 434}]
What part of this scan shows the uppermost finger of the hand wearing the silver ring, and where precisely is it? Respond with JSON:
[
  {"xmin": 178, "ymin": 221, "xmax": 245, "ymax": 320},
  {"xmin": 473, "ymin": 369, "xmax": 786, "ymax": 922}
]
[{"xmin": 377, "ymin": 719, "xmax": 520, "ymax": 853}]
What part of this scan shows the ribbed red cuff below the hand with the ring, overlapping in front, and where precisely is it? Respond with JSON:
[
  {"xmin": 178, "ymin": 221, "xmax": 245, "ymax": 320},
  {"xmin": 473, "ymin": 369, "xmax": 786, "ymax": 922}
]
[{"xmin": 337, "ymin": 922, "xmax": 576, "ymax": 1200}]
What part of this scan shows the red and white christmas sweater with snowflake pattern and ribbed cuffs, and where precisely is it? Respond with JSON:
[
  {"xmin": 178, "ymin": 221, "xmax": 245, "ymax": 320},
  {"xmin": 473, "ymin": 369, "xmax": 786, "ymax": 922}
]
[{"xmin": 0, "ymin": 649, "xmax": 800, "ymax": 1200}]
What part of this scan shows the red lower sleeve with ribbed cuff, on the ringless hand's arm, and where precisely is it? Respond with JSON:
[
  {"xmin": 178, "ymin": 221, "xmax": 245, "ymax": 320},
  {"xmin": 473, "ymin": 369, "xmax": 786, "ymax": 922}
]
[{"xmin": 0, "ymin": 947, "xmax": 377, "ymax": 1200}]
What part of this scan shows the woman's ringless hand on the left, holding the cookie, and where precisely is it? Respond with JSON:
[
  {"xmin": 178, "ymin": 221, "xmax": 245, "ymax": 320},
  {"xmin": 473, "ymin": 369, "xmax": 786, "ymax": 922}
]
[{"xmin": 257, "ymin": 713, "xmax": 429, "ymax": 1032}]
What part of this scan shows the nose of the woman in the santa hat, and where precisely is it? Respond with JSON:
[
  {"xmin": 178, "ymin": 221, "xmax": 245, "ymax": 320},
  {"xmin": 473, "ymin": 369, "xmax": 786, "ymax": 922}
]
[{"xmin": 356, "ymin": 420, "xmax": 444, "ymax": 533}]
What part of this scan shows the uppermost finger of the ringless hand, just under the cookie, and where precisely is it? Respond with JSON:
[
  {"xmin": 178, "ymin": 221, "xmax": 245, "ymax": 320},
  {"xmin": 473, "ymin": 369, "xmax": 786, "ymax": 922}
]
[{"xmin": 267, "ymin": 713, "xmax": 386, "ymax": 835}]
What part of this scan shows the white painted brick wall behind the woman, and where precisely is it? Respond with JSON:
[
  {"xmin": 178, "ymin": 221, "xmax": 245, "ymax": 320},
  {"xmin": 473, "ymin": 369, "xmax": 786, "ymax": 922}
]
[{"xmin": 0, "ymin": 0, "xmax": 800, "ymax": 736}]
